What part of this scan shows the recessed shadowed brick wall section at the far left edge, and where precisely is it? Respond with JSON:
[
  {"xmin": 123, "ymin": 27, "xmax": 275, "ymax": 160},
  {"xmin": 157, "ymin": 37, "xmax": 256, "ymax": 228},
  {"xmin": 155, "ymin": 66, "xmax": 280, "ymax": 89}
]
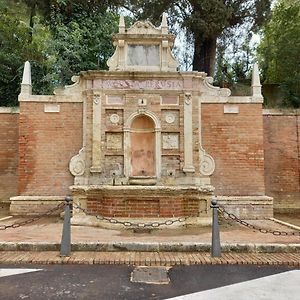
[{"xmin": 0, "ymin": 113, "xmax": 19, "ymax": 201}]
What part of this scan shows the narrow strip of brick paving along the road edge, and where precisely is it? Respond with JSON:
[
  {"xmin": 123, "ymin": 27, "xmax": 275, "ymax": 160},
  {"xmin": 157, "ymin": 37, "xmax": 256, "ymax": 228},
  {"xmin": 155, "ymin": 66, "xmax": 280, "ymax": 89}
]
[{"xmin": 0, "ymin": 251, "xmax": 300, "ymax": 267}]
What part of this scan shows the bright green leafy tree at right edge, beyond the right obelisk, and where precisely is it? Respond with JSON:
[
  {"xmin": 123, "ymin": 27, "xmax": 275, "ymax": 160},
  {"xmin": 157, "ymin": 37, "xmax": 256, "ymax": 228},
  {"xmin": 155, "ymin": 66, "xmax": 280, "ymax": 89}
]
[{"xmin": 258, "ymin": 0, "xmax": 300, "ymax": 107}]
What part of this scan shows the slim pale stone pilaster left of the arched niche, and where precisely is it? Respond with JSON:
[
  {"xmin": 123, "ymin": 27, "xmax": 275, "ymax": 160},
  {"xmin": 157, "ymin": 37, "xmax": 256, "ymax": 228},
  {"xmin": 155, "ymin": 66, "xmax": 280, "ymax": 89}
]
[{"xmin": 90, "ymin": 93, "xmax": 101, "ymax": 172}]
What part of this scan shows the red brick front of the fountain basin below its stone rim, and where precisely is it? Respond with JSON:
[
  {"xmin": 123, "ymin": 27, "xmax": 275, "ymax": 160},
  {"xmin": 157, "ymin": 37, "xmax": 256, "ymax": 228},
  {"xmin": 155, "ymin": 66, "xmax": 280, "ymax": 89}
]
[{"xmin": 87, "ymin": 197, "xmax": 201, "ymax": 218}]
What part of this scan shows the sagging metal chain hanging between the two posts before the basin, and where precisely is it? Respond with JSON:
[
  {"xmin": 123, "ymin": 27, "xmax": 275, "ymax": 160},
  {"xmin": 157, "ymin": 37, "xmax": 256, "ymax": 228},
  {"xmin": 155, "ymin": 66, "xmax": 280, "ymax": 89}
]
[{"xmin": 73, "ymin": 203, "xmax": 207, "ymax": 228}]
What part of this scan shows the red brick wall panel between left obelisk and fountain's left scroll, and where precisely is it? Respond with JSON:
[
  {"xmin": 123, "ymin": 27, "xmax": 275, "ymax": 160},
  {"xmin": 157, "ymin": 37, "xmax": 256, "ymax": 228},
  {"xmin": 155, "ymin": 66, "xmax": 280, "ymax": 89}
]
[{"xmin": 19, "ymin": 102, "xmax": 82, "ymax": 196}]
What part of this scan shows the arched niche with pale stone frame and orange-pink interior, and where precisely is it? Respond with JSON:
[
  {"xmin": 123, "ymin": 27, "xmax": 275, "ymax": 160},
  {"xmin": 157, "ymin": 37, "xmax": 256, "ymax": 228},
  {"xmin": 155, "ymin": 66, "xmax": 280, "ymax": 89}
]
[{"xmin": 124, "ymin": 110, "xmax": 161, "ymax": 179}]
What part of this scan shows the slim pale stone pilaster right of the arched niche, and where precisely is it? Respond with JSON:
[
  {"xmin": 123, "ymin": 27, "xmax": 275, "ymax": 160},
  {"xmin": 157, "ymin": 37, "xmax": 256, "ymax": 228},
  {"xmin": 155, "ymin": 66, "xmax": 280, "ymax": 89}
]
[{"xmin": 183, "ymin": 93, "xmax": 195, "ymax": 173}]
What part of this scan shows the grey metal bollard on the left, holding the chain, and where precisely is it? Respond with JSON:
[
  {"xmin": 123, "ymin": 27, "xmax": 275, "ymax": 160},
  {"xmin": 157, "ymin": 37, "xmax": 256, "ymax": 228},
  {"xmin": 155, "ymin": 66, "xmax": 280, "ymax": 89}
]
[{"xmin": 60, "ymin": 196, "xmax": 72, "ymax": 256}]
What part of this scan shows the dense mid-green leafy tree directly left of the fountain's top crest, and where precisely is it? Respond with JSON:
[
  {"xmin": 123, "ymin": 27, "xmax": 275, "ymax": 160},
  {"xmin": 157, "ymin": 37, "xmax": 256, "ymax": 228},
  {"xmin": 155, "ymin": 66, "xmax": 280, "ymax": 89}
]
[{"xmin": 47, "ymin": 11, "xmax": 118, "ymax": 86}]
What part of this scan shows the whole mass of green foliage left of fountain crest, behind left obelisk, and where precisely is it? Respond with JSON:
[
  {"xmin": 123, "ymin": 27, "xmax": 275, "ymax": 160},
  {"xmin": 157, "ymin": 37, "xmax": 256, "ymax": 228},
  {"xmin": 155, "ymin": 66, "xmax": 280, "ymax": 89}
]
[{"xmin": 0, "ymin": 0, "xmax": 118, "ymax": 106}]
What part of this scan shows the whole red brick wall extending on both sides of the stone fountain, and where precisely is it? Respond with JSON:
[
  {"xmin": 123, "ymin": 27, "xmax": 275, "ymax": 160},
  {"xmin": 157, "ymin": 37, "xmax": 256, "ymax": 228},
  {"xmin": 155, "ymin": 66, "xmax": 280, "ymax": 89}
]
[{"xmin": 4, "ymin": 102, "xmax": 300, "ymax": 210}]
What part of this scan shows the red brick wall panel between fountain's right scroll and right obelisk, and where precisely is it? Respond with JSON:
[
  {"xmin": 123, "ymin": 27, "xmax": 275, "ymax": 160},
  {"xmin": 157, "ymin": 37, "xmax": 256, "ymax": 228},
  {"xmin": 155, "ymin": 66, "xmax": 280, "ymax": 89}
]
[{"xmin": 202, "ymin": 104, "xmax": 265, "ymax": 196}]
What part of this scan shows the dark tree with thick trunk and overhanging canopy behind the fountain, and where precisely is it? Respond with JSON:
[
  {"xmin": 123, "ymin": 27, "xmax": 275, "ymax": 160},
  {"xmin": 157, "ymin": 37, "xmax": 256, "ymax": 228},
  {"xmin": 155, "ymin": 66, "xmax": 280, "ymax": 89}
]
[{"xmin": 125, "ymin": 0, "xmax": 271, "ymax": 76}]
